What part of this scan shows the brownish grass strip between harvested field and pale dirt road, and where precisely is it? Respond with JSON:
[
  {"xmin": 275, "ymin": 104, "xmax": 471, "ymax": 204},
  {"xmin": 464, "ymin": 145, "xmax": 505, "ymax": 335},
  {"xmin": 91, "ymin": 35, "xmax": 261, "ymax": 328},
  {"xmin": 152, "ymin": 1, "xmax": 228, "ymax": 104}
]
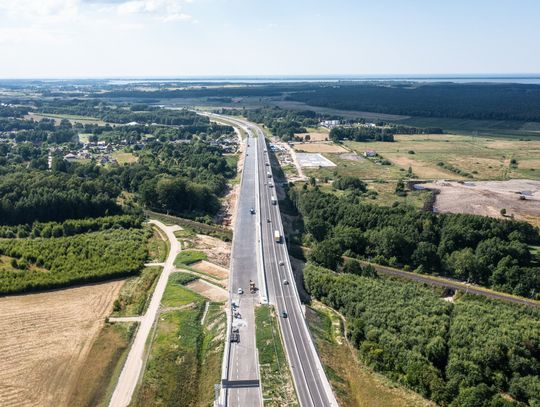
[{"xmin": 68, "ymin": 323, "xmax": 137, "ymax": 407}]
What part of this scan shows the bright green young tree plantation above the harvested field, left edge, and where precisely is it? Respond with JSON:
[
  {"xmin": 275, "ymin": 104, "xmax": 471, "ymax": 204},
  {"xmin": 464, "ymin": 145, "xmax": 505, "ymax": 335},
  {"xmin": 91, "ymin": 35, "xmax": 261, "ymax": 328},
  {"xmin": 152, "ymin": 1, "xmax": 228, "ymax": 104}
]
[{"xmin": 0, "ymin": 228, "xmax": 149, "ymax": 294}]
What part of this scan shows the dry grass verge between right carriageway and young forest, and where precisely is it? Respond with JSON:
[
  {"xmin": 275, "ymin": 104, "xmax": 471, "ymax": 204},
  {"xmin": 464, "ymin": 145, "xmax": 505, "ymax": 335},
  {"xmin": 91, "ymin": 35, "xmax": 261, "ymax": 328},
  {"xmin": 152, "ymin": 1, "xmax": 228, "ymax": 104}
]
[{"xmin": 307, "ymin": 302, "xmax": 434, "ymax": 407}]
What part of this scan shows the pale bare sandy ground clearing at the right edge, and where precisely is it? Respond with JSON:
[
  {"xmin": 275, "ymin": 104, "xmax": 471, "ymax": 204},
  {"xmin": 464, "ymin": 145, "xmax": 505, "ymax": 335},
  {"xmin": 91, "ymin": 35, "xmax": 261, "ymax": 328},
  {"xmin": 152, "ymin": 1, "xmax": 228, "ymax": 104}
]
[{"xmin": 424, "ymin": 180, "xmax": 540, "ymax": 226}]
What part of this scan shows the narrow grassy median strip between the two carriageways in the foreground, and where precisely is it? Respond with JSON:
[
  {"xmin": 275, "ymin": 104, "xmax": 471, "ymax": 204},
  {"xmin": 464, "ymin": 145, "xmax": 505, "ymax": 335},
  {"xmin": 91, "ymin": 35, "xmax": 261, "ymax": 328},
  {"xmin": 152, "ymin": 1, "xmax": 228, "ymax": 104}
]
[{"xmin": 255, "ymin": 305, "xmax": 299, "ymax": 407}]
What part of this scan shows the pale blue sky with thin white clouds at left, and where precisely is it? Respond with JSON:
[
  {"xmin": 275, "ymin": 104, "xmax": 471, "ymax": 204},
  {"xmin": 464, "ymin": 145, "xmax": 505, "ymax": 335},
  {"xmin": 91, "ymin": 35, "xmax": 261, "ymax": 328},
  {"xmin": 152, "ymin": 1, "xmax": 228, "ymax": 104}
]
[{"xmin": 0, "ymin": 0, "xmax": 540, "ymax": 78}]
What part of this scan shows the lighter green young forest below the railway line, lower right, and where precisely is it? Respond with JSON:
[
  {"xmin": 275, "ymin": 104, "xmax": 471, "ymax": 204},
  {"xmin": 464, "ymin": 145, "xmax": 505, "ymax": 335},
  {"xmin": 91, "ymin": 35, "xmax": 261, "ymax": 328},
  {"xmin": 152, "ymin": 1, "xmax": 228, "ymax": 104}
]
[{"xmin": 304, "ymin": 264, "xmax": 540, "ymax": 407}]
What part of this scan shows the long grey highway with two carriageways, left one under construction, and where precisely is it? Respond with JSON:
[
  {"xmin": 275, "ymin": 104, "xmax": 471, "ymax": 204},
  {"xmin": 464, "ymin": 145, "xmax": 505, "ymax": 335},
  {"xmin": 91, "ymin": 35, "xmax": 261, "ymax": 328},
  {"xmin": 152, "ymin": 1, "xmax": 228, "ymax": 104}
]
[{"xmin": 210, "ymin": 115, "xmax": 338, "ymax": 407}]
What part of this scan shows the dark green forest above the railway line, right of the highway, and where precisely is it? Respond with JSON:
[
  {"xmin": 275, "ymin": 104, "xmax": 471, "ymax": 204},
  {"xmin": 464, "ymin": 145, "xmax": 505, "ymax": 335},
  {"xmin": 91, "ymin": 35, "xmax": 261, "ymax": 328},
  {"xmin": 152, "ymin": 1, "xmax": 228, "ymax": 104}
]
[{"xmin": 289, "ymin": 187, "xmax": 540, "ymax": 299}]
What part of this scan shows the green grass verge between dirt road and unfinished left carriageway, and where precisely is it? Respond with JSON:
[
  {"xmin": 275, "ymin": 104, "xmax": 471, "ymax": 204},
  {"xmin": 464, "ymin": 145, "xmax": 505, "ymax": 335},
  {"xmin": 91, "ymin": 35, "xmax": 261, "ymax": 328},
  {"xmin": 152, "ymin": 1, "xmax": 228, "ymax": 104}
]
[{"xmin": 132, "ymin": 281, "xmax": 226, "ymax": 407}]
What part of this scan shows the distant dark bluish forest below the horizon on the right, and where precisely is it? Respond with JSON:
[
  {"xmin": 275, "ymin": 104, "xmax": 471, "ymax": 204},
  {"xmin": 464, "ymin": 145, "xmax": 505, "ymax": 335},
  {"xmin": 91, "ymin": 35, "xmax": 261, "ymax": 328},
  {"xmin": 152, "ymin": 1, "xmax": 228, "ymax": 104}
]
[{"xmin": 287, "ymin": 82, "xmax": 540, "ymax": 121}]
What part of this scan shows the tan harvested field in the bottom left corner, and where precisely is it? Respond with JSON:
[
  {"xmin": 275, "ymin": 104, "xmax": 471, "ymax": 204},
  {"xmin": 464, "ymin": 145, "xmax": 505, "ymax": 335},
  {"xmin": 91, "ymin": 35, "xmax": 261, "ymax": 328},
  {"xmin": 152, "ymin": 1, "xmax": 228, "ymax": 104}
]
[{"xmin": 0, "ymin": 281, "xmax": 123, "ymax": 407}]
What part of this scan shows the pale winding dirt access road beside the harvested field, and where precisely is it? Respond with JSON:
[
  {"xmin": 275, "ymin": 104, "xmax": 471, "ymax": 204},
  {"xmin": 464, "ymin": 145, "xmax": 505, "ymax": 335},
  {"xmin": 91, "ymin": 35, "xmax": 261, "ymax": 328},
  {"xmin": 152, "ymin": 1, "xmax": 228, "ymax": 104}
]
[{"xmin": 109, "ymin": 220, "xmax": 181, "ymax": 407}]
